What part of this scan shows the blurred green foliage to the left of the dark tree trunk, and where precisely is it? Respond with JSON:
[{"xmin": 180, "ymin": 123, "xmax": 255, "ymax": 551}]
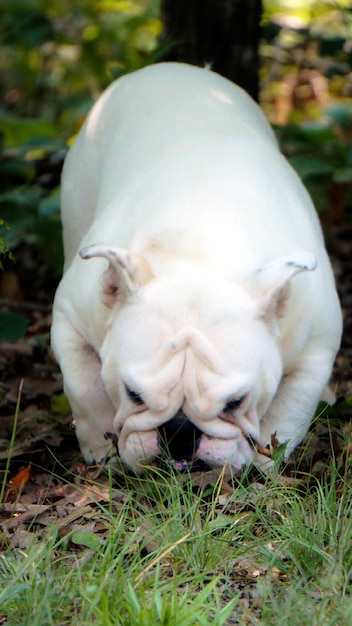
[{"xmin": 0, "ymin": 0, "xmax": 161, "ymax": 276}]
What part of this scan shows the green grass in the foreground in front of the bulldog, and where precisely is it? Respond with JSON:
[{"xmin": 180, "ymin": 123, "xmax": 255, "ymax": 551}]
[{"xmin": 0, "ymin": 450, "xmax": 352, "ymax": 626}]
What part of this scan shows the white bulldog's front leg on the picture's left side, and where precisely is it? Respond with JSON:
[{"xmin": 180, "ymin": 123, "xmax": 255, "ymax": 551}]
[{"xmin": 51, "ymin": 312, "xmax": 116, "ymax": 463}]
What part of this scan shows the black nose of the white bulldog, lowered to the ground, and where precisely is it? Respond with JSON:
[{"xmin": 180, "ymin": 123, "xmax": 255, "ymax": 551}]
[{"xmin": 157, "ymin": 409, "xmax": 202, "ymax": 461}]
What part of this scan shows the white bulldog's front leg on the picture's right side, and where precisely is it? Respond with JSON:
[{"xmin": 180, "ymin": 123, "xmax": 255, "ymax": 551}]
[{"xmin": 260, "ymin": 351, "xmax": 334, "ymax": 458}]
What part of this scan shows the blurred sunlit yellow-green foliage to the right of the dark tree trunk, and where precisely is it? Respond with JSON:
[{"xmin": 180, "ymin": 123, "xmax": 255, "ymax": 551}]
[{"xmin": 261, "ymin": 0, "xmax": 352, "ymax": 211}]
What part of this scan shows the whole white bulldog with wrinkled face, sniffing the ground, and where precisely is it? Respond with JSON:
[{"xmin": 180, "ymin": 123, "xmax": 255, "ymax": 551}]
[{"xmin": 52, "ymin": 63, "xmax": 341, "ymax": 472}]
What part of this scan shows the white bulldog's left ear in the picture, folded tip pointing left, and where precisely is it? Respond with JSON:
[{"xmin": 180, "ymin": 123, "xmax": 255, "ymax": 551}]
[{"xmin": 79, "ymin": 243, "xmax": 147, "ymax": 307}]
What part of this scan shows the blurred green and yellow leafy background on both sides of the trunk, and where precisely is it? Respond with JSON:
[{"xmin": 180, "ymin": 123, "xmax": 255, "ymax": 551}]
[{"xmin": 0, "ymin": 0, "xmax": 352, "ymax": 277}]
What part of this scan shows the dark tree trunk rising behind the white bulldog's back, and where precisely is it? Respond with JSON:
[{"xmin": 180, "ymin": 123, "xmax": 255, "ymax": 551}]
[{"xmin": 161, "ymin": 0, "xmax": 262, "ymax": 100}]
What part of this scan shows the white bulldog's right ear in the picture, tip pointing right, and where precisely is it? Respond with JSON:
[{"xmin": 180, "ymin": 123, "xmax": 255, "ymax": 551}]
[{"xmin": 251, "ymin": 250, "xmax": 317, "ymax": 322}]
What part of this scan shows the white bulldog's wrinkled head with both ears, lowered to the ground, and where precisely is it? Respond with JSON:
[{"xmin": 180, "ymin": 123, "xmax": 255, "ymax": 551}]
[{"xmin": 80, "ymin": 244, "xmax": 315, "ymax": 471}]
